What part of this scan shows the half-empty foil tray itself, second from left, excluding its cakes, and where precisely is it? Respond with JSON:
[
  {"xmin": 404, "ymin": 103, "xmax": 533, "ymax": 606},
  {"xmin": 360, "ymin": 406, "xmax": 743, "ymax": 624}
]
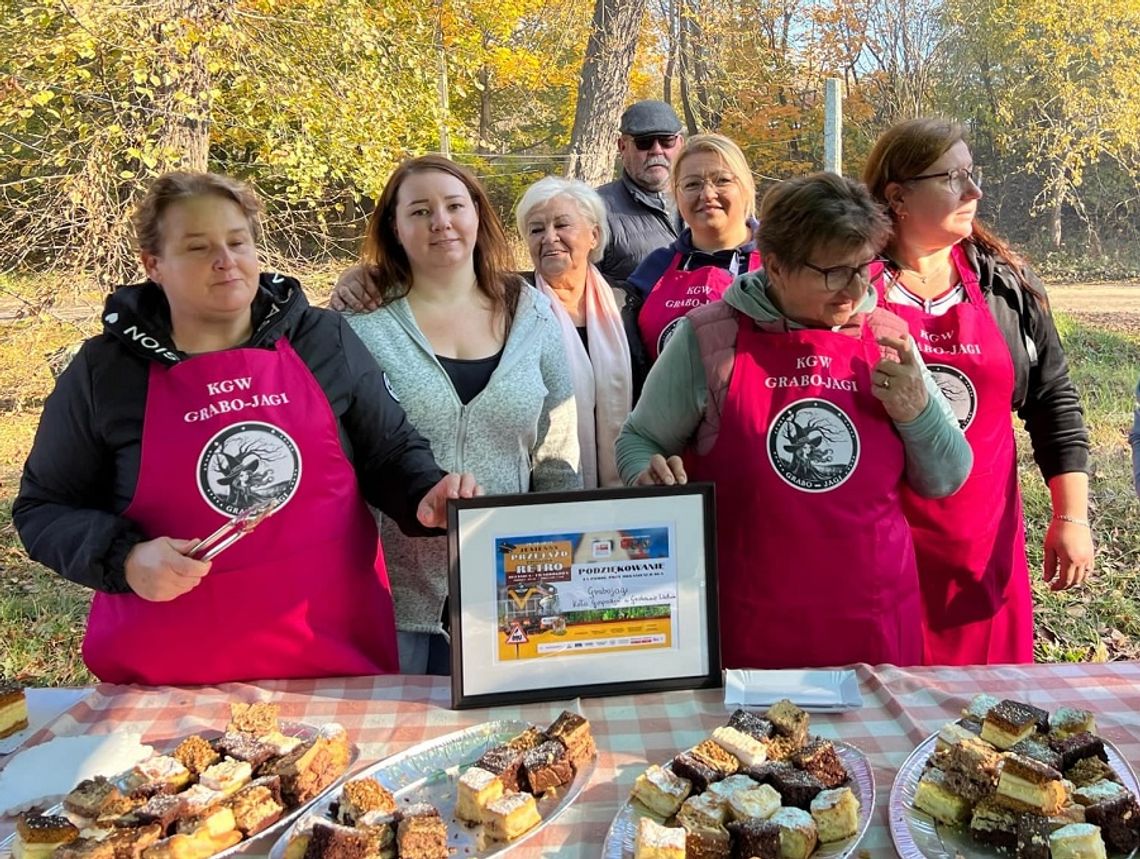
[{"xmin": 269, "ymin": 719, "xmax": 597, "ymax": 859}]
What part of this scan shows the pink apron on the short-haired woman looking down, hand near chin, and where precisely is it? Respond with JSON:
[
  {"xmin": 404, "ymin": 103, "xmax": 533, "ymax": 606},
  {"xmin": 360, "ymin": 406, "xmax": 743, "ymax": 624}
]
[{"xmin": 685, "ymin": 320, "xmax": 922, "ymax": 668}]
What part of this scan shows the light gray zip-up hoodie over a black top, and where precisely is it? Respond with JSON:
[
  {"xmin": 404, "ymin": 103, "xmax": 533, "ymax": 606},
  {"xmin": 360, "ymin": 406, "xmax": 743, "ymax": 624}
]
[{"xmin": 348, "ymin": 287, "xmax": 581, "ymax": 632}]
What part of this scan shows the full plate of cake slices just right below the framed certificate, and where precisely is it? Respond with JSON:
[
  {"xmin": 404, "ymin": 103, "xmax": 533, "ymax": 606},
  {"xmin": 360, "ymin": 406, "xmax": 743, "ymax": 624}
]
[{"xmin": 602, "ymin": 700, "xmax": 874, "ymax": 859}]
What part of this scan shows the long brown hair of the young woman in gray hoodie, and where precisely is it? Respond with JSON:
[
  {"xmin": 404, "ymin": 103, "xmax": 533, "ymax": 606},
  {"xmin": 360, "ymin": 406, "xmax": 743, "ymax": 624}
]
[{"xmin": 360, "ymin": 155, "xmax": 522, "ymax": 318}]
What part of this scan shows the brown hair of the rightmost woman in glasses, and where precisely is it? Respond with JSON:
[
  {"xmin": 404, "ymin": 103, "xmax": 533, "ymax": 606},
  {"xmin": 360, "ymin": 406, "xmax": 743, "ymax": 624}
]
[{"xmin": 863, "ymin": 117, "xmax": 1042, "ymax": 298}]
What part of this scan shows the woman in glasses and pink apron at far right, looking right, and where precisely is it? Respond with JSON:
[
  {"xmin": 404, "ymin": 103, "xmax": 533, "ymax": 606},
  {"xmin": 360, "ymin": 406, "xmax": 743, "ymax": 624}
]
[{"xmin": 863, "ymin": 118, "xmax": 1093, "ymax": 664}]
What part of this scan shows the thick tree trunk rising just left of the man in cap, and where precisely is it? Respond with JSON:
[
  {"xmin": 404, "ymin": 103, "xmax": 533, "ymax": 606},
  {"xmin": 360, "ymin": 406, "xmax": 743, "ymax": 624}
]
[{"xmin": 567, "ymin": 0, "xmax": 645, "ymax": 185}]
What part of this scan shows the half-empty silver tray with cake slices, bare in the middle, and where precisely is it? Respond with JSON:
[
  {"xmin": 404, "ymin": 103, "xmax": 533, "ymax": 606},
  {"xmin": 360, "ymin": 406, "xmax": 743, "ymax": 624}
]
[{"xmin": 269, "ymin": 711, "xmax": 597, "ymax": 859}]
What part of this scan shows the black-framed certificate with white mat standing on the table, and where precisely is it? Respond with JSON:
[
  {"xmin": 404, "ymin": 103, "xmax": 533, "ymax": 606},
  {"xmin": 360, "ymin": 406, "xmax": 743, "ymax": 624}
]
[{"xmin": 448, "ymin": 483, "xmax": 720, "ymax": 709}]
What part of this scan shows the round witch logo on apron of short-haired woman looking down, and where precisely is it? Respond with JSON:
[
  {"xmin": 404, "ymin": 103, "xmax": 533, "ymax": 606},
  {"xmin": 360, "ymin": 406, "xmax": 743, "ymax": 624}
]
[{"xmin": 767, "ymin": 399, "xmax": 860, "ymax": 492}]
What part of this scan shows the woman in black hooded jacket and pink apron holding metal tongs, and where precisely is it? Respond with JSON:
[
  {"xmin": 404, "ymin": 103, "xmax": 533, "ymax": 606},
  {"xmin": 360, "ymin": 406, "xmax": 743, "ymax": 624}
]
[{"xmin": 13, "ymin": 173, "xmax": 477, "ymax": 685}]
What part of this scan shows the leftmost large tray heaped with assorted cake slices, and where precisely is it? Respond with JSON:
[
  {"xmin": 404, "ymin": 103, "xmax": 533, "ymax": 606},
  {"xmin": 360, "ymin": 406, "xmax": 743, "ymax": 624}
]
[{"xmin": 0, "ymin": 703, "xmax": 357, "ymax": 859}]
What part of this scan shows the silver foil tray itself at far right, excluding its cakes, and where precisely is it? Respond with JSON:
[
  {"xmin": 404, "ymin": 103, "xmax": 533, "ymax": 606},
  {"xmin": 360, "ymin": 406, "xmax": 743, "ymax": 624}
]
[{"xmin": 889, "ymin": 734, "xmax": 1140, "ymax": 859}]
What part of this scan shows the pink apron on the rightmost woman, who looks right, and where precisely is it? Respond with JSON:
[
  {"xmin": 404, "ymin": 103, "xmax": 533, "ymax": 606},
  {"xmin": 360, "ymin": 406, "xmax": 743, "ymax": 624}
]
[{"xmin": 879, "ymin": 245, "xmax": 1033, "ymax": 665}]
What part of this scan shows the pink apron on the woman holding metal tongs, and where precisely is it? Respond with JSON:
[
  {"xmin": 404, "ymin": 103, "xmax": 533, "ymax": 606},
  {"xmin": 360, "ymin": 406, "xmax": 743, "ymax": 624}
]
[{"xmin": 83, "ymin": 338, "xmax": 399, "ymax": 685}]
